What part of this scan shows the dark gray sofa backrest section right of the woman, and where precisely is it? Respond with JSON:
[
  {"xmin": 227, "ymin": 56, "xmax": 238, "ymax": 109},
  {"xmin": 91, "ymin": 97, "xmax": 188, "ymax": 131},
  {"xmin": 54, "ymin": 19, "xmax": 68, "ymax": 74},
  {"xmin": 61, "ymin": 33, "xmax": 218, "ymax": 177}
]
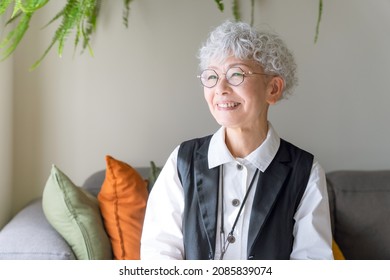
[{"xmin": 327, "ymin": 171, "xmax": 390, "ymax": 260}]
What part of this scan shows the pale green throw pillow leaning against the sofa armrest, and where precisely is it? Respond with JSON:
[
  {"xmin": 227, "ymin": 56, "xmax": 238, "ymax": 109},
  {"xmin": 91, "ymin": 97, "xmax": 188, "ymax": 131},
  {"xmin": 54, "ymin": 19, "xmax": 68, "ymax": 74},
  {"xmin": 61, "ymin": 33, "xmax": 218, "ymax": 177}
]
[{"xmin": 42, "ymin": 165, "xmax": 112, "ymax": 260}]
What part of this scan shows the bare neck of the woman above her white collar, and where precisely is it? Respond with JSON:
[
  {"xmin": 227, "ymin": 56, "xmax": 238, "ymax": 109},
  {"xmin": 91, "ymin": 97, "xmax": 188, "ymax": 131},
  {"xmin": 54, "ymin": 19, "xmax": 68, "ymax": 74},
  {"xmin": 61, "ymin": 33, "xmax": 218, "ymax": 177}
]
[{"xmin": 225, "ymin": 122, "xmax": 268, "ymax": 158}]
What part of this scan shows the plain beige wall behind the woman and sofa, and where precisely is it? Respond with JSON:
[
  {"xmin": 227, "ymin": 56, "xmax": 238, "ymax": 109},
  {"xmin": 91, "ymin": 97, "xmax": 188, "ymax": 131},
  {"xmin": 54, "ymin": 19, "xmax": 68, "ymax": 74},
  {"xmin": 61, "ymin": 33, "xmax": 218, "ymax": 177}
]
[{"xmin": 5, "ymin": 0, "xmax": 390, "ymax": 219}]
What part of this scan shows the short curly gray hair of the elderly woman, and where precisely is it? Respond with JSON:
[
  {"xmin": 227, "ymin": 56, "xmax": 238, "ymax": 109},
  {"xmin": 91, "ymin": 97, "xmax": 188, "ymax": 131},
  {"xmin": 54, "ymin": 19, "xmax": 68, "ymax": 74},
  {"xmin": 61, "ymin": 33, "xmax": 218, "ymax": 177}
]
[{"xmin": 199, "ymin": 21, "xmax": 298, "ymax": 98}]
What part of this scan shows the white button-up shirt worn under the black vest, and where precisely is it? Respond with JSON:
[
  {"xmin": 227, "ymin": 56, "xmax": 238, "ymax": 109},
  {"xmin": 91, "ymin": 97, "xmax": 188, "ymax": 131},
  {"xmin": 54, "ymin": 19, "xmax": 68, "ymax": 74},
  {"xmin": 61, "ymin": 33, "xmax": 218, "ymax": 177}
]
[{"xmin": 141, "ymin": 123, "xmax": 333, "ymax": 260}]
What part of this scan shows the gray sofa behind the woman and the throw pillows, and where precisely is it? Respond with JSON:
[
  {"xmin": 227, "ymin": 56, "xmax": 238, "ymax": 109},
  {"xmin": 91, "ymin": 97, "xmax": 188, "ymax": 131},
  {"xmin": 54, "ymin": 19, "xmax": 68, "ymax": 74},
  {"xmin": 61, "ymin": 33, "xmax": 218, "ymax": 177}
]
[{"xmin": 0, "ymin": 168, "xmax": 390, "ymax": 260}]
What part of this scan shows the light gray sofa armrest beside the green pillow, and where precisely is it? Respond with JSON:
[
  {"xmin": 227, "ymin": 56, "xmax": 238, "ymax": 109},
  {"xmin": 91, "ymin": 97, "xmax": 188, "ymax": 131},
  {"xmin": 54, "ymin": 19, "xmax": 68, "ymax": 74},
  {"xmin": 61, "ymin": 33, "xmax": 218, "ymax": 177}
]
[{"xmin": 0, "ymin": 199, "xmax": 75, "ymax": 260}]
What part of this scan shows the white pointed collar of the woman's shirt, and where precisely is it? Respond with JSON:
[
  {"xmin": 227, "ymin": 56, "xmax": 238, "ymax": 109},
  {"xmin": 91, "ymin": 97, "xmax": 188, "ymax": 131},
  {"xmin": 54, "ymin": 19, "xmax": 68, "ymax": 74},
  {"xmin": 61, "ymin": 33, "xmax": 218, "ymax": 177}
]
[{"xmin": 208, "ymin": 123, "xmax": 280, "ymax": 172}]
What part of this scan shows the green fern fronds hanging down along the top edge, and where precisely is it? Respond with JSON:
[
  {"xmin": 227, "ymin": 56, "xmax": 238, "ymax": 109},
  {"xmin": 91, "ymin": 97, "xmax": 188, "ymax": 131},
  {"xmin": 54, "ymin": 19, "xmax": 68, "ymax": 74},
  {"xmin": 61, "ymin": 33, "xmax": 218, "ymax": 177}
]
[{"xmin": 0, "ymin": 0, "xmax": 323, "ymax": 70}]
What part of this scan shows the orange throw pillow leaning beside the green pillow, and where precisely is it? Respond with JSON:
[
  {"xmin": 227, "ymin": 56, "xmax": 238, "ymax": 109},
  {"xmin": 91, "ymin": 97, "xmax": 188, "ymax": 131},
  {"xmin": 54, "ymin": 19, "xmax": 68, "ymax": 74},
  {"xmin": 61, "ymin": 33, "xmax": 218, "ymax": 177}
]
[{"xmin": 98, "ymin": 156, "xmax": 148, "ymax": 260}]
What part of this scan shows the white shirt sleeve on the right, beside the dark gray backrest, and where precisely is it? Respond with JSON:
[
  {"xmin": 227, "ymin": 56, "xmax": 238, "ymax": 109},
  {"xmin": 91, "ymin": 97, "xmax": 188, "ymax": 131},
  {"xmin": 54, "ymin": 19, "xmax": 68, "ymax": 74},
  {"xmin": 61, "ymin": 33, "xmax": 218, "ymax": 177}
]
[{"xmin": 290, "ymin": 160, "xmax": 333, "ymax": 259}]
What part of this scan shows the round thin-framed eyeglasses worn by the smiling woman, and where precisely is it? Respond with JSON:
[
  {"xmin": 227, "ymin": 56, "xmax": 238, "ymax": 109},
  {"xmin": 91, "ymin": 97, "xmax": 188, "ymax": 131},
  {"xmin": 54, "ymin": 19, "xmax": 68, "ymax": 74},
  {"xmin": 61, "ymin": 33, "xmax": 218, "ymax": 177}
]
[{"xmin": 198, "ymin": 67, "xmax": 274, "ymax": 88}]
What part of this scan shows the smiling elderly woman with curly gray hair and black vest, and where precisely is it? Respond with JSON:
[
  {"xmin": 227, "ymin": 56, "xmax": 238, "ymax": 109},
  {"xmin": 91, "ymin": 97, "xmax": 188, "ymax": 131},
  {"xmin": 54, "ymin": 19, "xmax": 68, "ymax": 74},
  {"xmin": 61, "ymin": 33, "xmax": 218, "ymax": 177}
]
[{"xmin": 141, "ymin": 21, "xmax": 333, "ymax": 260}]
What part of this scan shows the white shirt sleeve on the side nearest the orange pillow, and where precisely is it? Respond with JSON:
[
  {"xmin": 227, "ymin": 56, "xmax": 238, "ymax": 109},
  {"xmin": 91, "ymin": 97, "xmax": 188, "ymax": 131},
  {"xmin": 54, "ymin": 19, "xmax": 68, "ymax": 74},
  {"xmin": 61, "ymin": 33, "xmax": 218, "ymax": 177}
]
[{"xmin": 141, "ymin": 147, "xmax": 184, "ymax": 260}]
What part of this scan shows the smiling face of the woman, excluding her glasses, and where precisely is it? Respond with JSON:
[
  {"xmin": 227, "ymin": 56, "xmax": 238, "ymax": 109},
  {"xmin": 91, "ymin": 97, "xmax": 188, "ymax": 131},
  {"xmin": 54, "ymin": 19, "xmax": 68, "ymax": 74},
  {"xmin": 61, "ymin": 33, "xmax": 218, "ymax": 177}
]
[{"xmin": 204, "ymin": 57, "xmax": 281, "ymax": 129}]
